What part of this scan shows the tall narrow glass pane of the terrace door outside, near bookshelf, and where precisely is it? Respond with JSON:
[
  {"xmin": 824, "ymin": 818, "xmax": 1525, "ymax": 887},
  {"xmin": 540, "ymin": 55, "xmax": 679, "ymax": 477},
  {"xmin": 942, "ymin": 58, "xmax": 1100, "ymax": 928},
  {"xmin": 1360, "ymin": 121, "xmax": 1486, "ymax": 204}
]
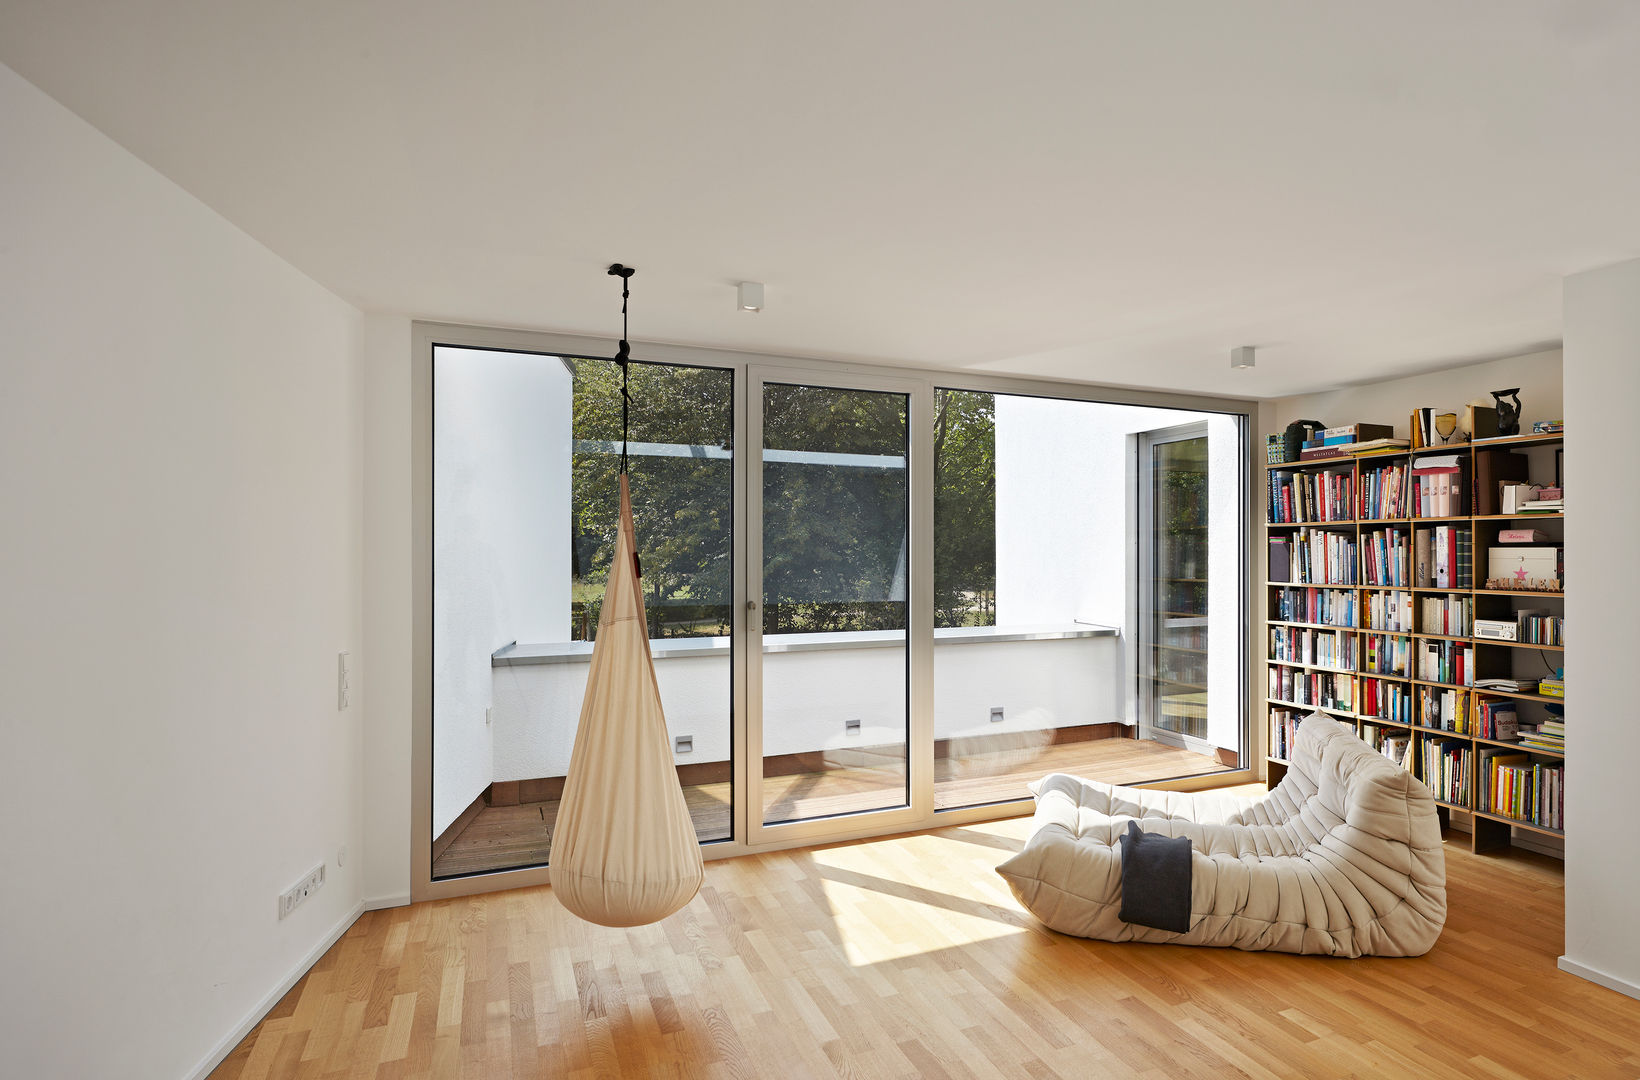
[{"xmin": 1145, "ymin": 434, "xmax": 1210, "ymax": 741}]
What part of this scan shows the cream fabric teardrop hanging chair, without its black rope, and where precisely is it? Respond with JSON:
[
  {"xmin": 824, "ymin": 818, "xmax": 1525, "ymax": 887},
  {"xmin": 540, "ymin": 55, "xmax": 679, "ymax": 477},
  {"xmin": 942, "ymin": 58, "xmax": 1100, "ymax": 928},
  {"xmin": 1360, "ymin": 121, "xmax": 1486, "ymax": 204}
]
[{"xmin": 548, "ymin": 472, "xmax": 705, "ymax": 926}]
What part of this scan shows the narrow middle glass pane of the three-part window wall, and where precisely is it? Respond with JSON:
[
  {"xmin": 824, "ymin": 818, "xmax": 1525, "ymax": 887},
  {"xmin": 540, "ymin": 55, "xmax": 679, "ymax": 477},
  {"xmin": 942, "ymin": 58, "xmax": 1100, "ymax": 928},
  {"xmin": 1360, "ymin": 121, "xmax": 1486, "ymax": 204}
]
[{"xmin": 763, "ymin": 383, "xmax": 909, "ymax": 824}]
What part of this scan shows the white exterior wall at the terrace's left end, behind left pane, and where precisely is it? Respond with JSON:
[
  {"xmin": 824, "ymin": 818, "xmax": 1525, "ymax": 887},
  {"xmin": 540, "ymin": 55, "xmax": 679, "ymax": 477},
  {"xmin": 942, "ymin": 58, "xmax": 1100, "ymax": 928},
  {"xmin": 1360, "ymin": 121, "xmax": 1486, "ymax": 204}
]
[{"xmin": 433, "ymin": 347, "xmax": 574, "ymax": 836}]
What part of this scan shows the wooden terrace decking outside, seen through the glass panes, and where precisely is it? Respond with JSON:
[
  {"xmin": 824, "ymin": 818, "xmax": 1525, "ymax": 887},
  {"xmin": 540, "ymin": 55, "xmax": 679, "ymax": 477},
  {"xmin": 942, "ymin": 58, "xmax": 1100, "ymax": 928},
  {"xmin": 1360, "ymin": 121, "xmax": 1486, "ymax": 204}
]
[{"xmin": 433, "ymin": 733, "xmax": 1227, "ymax": 877}]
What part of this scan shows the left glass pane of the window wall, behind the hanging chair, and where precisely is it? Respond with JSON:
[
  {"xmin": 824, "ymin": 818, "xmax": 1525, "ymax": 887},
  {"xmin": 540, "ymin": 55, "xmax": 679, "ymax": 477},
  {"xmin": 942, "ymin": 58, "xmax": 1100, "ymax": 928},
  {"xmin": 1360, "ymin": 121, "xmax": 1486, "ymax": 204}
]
[{"xmin": 433, "ymin": 346, "xmax": 735, "ymax": 877}]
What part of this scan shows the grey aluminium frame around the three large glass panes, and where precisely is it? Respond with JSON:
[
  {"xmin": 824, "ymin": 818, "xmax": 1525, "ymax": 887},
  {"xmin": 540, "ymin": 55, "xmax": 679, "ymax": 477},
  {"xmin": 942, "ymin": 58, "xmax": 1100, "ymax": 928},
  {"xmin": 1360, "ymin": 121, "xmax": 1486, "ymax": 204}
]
[{"xmin": 405, "ymin": 320, "xmax": 1263, "ymax": 901}]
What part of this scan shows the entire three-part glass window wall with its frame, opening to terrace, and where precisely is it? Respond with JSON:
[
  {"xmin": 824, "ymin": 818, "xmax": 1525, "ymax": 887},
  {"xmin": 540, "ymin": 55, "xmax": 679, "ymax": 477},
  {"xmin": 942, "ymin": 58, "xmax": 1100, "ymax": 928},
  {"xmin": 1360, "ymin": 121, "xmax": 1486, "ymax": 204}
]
[{"xmin": 415, "ymin": 331, "xmax": 1246, "ymax": 895}]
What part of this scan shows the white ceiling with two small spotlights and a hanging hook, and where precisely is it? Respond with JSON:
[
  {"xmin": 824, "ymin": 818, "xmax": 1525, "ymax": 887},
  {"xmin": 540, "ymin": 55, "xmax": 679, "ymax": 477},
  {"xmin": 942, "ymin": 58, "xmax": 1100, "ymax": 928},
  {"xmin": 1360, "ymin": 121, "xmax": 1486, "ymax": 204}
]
[{"xmin": 0, "ymin": 0, "xmax": 1640, "ymax": 397}]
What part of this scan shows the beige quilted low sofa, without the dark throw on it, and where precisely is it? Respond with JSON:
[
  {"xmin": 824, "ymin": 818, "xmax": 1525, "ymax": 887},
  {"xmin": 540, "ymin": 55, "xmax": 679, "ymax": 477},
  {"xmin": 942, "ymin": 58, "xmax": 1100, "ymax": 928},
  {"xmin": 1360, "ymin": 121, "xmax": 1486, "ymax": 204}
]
[{"xmin": 997, "ymin": 715, "xmax": 1446, "ymax": 957}]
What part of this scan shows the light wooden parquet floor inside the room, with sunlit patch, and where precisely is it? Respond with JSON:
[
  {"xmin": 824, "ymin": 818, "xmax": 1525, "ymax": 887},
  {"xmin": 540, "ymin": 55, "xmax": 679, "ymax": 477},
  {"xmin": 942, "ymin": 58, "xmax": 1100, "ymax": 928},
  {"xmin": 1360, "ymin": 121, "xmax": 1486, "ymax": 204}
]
[{"xmin": 213, "ymin": 818, "xmax": 1640, "ymax": 1080}]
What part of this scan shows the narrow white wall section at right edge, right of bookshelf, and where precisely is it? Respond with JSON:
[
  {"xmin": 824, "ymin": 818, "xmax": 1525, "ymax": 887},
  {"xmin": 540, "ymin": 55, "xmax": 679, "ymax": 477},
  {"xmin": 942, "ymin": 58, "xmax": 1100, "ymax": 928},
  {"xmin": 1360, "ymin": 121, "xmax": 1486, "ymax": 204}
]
[{"xmin": 1561, "ymin": 261, "xmax": 1640, "ymax": 996}]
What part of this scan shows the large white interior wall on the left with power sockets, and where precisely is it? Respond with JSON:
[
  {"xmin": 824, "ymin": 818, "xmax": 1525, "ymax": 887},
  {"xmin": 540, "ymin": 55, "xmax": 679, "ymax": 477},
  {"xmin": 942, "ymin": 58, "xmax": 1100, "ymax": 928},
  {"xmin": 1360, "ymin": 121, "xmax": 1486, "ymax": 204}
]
[{"xmin": 0, "ymin": 58, "xmax": 367, "ymax": 1080}]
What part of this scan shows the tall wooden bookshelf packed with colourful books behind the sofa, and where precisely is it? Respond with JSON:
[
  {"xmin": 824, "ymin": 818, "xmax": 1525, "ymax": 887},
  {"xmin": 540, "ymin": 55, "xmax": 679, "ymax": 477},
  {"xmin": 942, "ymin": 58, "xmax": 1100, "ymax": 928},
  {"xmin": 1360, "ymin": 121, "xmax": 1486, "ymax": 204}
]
[{"xmin": 1263, "ymin": 433, "xmax": 1566, "ymax": 851}]
